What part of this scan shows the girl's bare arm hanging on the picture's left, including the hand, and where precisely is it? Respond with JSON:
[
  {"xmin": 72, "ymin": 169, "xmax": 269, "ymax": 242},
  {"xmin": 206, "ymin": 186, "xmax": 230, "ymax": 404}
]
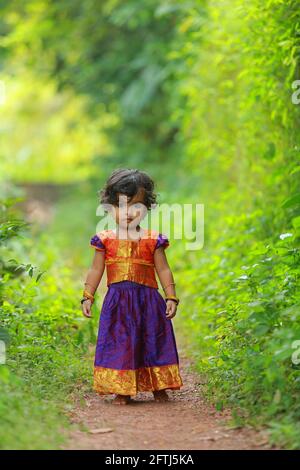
[{"xmin": 82, "ymin": 250, "xmax": 105, "ymax": 317}]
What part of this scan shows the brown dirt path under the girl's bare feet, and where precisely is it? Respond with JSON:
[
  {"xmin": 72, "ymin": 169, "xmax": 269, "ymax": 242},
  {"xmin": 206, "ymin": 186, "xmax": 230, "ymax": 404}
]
[{"xmin": 61, "ymin": 338, "xmax": 276, "ymax": 450}]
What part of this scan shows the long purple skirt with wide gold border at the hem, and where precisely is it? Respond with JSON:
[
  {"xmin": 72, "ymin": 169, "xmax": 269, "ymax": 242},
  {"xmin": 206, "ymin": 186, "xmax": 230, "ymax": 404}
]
[{"xmin": 93, "ymin": 281, "xmax": 183, "ymax": 395}]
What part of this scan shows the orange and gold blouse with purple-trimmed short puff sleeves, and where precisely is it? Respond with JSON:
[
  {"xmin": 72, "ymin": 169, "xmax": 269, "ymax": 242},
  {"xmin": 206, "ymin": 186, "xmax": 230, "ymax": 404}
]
[{"xmin": 90, "ymin": 229, "xmax": 169, "ymax": 289}]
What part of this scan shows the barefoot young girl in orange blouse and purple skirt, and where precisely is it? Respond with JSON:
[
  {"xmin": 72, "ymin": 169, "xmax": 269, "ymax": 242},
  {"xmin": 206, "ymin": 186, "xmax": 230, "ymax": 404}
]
[{"xmin": 81, "ymin": 169, "xmax": 183, "ymax": 404}]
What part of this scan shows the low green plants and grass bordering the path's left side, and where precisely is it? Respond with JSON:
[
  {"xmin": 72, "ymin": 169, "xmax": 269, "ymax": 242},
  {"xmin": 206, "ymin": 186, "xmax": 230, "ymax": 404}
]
[{"xmin": 0, "ymin": 193, "xmax": 96, "ymax": 449}]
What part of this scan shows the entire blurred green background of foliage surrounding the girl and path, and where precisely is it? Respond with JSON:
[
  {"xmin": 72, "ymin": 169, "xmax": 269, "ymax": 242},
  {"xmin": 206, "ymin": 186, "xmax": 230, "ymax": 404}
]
[{"xmin": 0, "ymin": 0, "xmax": 300, "ymax": 449}]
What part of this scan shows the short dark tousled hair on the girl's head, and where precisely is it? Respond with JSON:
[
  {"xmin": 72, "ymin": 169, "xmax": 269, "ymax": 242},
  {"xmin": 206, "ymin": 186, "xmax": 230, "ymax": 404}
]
[{"xmin": 98, "ymin": 168, "xmax": 157, "ymax": 210}]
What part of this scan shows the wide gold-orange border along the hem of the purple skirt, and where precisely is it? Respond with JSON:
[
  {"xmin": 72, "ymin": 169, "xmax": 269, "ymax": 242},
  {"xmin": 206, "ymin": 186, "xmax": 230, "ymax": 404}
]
[{"xmin": 93, "ymin": 364, "xmax": 183, "ymax": 395}]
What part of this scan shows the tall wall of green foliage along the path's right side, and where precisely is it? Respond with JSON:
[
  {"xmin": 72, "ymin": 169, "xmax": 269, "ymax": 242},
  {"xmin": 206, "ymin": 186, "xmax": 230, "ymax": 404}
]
[{"xmin": 164, "ymin": 0, "xmax": 300, "ymax": 448}]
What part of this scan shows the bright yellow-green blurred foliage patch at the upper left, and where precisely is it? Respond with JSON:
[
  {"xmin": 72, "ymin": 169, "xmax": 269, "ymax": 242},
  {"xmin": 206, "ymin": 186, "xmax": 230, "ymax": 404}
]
[{"xmin": 0, "ymin": 72, "xmax": 113, "ymax": 183}]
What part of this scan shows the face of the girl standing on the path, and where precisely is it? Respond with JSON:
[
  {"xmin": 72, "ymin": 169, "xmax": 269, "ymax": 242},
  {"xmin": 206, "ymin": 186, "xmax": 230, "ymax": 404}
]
[{"xmin": 110, "ymin": 189, "xmax": 147, "ymax": 228}]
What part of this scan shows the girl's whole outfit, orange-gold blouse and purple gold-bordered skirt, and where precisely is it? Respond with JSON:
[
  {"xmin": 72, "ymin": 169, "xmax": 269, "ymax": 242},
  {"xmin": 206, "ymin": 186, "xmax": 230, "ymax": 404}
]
[{"xmin": 90, "ymin": 229, "xmax": 183, "ymax": 395}]
